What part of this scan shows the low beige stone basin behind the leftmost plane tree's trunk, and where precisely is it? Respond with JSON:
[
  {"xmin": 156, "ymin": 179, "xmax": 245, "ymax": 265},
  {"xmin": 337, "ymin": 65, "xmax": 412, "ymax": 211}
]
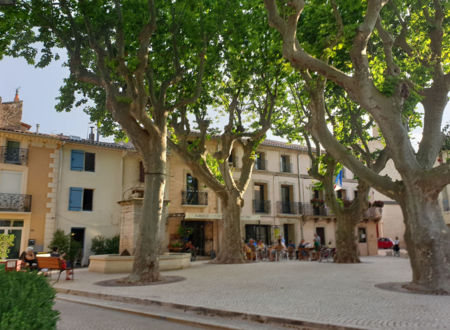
[{"xmin": 89, "ymin": 253, "xmax": 191, "ymax": 274}]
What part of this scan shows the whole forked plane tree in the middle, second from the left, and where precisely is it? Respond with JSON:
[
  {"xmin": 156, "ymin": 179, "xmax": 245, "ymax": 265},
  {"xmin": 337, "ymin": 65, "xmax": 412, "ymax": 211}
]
[{"xmin": 170, "ymin": 1, "xmax": 292, "ymax": 263}]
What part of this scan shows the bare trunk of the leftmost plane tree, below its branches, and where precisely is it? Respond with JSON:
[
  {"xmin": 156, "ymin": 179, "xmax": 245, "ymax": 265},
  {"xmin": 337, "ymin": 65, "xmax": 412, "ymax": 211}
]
[{"xmin": 128, "ymin": 137, "xmax": 166, "ymax": 282}]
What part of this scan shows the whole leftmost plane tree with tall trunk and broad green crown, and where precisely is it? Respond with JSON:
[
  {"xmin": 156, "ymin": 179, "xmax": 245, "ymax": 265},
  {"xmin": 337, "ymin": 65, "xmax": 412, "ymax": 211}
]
[{"xmin": 0, "ymin": 0, "xmax": 222, "ymax": 282}]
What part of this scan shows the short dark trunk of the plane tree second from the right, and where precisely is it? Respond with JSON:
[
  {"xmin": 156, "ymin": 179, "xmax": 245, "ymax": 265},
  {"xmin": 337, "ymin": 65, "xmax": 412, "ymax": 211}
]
[{"xmin": 334, "ymin": 211, "xmax": 362, "ymax": 264}]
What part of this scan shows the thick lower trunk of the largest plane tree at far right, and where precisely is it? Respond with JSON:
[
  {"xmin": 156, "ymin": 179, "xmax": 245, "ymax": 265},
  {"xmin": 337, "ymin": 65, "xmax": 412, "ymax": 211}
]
[{"xmin": 399, "ymin": 187, "xmax": 450, "ymax": 294}]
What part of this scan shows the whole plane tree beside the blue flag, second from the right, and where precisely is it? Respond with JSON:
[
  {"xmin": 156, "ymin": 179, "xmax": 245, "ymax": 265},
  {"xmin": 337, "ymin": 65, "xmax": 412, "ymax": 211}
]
[{"xmin": 274, "ymin": 78, "xmax": 388, "ymax": 263}]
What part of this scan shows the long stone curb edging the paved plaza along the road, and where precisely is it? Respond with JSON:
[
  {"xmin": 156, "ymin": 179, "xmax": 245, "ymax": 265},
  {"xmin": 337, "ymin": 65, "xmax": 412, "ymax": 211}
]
[{"xmin": 56, "ymin": 288, "xmax": 359, "ymax": 330}]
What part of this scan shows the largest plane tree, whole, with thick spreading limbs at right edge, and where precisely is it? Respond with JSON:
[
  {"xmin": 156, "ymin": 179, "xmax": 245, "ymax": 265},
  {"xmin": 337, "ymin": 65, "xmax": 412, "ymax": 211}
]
[{"xmin": 265, "ymin": 0, "xmax": 450, "ymax": 293}]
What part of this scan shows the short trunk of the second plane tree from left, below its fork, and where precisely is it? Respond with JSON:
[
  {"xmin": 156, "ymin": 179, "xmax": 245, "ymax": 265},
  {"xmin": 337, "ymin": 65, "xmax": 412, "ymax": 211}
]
[{"xmin": 214, "ymin": 193, "xmax": 245, "ymax": 264}]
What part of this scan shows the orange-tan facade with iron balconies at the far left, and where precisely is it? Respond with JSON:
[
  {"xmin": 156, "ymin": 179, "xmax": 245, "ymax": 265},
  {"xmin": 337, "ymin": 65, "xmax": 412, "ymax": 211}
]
[{"xmin": 0, "ymin": 130, "xmax": 59, "ymax": 257}]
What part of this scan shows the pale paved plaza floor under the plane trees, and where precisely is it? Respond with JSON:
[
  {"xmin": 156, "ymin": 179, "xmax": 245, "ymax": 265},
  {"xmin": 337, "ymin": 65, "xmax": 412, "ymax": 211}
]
[{"xmin": 55, "ymin": 256, "xmax": 450, "ymax": 329}]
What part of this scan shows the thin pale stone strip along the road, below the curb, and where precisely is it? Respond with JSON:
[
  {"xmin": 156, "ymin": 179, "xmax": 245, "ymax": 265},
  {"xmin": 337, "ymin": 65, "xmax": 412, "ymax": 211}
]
[{"xmin": 56, "ymin": 297, "xmax": 237, "ymax": 330}]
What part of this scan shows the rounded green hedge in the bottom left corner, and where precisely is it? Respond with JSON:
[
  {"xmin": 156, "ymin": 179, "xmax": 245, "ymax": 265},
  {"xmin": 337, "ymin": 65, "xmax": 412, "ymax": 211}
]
[{"xmin": 0, "ymin": 270, "xmax": 59, "ymax": 330}]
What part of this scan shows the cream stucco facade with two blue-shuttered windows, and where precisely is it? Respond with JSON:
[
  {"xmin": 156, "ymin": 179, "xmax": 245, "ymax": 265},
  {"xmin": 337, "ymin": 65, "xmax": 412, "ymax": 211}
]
[{"xmin": 56, "ymin": 141, "xmax": 126, "ymax": 264}]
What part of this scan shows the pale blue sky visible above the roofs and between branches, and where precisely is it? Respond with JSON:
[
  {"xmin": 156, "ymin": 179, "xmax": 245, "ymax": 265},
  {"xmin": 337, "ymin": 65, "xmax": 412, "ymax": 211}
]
[{"xmin": 0, "ymin": 57, "xmax": 450, "ymax": 144}]
